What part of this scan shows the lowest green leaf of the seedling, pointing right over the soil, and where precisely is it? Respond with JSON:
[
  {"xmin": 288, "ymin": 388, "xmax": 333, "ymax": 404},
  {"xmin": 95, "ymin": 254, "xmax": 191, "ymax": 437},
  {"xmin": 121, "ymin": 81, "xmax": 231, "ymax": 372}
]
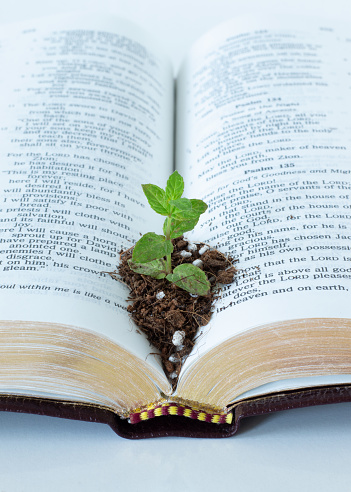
[{"xmin": 166, "ymin": 263, "xmax": 211, "ymax": 296}]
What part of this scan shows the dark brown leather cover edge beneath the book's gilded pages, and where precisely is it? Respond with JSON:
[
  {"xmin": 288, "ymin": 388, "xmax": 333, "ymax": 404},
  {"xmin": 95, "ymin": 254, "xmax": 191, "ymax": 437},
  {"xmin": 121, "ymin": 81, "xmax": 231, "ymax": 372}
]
[{"xmin": 0, "ymin": 385, "xmax": 351, "ymax": 439}]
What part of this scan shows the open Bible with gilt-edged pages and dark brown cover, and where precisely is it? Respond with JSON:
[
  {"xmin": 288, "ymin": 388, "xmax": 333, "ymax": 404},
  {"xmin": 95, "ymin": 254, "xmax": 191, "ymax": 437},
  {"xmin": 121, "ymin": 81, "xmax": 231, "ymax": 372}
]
[{"xmin": 0, "ymin": 12, "xmax": 351, "ymax": 438}]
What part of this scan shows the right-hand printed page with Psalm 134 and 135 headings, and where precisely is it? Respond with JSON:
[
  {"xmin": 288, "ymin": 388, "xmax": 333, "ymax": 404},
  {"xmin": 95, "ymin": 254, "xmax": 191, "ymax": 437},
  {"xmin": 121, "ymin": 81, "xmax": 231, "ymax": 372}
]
[{"xmin": 176, "ymin": 15, "xmax": 351, "ymax": 367}]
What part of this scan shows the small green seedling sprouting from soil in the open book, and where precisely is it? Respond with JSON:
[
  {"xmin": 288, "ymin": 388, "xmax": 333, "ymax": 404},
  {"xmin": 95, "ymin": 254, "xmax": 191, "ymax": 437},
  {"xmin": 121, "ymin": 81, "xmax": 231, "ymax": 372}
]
[{"xmin": 128, "ymin": 171, "xmax": 210, "ymax": 296}]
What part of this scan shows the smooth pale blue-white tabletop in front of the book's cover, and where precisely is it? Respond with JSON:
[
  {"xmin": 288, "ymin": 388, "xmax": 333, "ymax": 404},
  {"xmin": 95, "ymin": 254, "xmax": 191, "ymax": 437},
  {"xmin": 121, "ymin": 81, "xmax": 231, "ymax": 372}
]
[{"xmin": 0, "ymin": 404, "xmax": 351, "ymax": 492}]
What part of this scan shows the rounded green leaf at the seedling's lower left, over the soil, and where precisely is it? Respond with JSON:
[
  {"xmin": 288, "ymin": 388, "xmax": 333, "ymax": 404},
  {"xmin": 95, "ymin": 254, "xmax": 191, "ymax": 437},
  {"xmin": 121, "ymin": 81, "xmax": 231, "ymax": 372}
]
[{"xmin": 132, "ymin": 232, "xmax": 173, "ymax": 263}]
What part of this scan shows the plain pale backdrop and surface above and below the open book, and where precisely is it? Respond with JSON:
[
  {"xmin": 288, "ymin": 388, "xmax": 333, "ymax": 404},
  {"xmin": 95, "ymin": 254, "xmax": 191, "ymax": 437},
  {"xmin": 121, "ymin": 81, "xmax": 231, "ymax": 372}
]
[{"xmin": 0, "ymin": 0, "xmax": 351, "ymax": 492}]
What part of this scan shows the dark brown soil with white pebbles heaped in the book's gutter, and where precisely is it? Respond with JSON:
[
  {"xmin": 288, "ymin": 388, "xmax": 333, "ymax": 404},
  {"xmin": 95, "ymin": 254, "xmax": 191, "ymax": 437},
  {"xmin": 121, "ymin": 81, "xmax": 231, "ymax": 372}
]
[{"xmin": 109, "ymin": 237, "xmax": 237, "ymax": 386}]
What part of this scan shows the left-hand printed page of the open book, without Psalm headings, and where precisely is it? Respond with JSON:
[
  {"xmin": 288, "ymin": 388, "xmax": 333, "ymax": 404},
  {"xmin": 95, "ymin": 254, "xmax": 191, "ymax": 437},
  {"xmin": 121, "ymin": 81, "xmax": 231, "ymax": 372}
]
[{"xmin": 0, "ymin": 16, "xmax": 174, "ymax": 371}]
